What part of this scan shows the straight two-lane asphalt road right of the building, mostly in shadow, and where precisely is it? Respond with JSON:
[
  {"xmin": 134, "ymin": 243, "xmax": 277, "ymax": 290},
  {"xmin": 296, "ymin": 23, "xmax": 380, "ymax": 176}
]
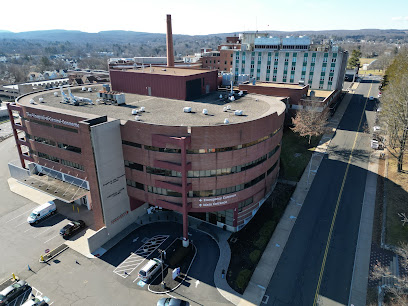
[{"xmin": 266, "ymin": 81, "xmax": 378, "ymax": 305}]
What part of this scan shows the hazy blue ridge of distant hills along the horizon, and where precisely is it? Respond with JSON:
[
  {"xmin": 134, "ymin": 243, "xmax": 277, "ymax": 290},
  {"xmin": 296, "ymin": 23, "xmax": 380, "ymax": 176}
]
[{"xmin": 0, "ymin": 29, "xmax": 408, "ymax": 44}]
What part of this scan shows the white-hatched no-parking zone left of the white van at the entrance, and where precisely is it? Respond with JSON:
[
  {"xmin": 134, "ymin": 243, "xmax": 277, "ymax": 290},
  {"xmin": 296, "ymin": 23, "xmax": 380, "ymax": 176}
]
[{"xmin": 113, "ymin": 235, "xmax": 170, "ymax": 279}]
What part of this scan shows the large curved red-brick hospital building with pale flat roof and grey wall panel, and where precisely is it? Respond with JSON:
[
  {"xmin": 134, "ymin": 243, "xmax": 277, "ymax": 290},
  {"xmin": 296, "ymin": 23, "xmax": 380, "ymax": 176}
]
[{"xmin": 8, "ymin": 86, "xmax": 285, "ymax": 251}]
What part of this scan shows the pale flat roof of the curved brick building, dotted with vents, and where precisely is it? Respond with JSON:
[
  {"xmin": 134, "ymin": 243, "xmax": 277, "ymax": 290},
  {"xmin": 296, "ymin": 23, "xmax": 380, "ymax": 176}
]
[{"xmin": 18, "ymin": 85, "xmax": 285, "ymax": 126}]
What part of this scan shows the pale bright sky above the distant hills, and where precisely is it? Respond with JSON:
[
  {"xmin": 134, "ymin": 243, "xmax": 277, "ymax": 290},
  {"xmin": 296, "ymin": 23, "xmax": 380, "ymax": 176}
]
[{"xmin": 0, "ymin": 0, "xmax": 408, "ymax": 35}]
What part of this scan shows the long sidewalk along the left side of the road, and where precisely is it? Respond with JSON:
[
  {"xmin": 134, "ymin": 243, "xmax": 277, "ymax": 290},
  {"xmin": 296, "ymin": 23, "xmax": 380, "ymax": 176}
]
[{"xmin": 234, "ymin": 89, "xmax": 358, "ymax": 306}]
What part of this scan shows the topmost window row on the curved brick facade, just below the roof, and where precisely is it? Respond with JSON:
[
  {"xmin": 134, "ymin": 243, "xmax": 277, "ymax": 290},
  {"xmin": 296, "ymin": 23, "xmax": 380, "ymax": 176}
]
[{"xmin": 122, "ymin": 127, "xmax": 282, "ymax": 154}]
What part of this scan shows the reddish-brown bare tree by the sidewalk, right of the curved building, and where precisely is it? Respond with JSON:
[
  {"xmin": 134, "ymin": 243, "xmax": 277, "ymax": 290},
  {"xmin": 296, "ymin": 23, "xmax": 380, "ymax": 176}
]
[{"xmin": 291, "ymin": 108, "xmax": 329, "ymax": 144}]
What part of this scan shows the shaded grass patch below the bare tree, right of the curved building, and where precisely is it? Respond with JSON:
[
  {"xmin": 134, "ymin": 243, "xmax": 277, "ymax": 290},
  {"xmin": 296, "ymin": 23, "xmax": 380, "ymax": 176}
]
[{"xmin": 280, "ymin": 128, "xmax": 321, "ymax": 182}]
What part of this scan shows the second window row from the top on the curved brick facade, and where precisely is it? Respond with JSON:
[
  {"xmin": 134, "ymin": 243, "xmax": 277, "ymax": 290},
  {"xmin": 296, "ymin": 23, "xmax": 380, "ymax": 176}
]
[{"xmin": 125, "ymin": 144, "xmax": 280, "ymax": 178}]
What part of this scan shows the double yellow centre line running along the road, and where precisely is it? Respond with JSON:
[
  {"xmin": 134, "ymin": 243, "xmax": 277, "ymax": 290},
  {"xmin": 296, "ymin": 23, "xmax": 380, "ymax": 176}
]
[{"xmin": 313, "ymin": 82, "xmax": 373, "ymax": 306}]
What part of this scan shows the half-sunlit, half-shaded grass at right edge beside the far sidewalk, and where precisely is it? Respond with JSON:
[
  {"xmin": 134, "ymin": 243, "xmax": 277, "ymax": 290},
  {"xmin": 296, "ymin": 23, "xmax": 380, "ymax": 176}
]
[{"xmin": 385, "ymin": 154, "xmax": 408, "ymax": 246}]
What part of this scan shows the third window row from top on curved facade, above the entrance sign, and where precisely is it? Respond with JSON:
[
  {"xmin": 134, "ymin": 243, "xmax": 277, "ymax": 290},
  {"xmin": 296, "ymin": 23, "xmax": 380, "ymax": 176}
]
[{"xmin": 135, "ymin": 161, "xmax": 278, "ymax": 198}]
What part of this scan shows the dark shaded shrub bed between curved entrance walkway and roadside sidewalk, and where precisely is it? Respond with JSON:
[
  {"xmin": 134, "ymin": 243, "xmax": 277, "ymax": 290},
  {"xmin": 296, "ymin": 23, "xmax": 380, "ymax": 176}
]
[{"xmin": 227, "ymin": 184, "xmax": 295, "ymax": 294}]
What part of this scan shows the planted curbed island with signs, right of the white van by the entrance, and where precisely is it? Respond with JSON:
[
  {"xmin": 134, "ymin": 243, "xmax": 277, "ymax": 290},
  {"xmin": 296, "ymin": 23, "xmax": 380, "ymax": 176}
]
[{"xmin": 148, "ymin": 239, "xmax": 197, "ymax": 294}]
